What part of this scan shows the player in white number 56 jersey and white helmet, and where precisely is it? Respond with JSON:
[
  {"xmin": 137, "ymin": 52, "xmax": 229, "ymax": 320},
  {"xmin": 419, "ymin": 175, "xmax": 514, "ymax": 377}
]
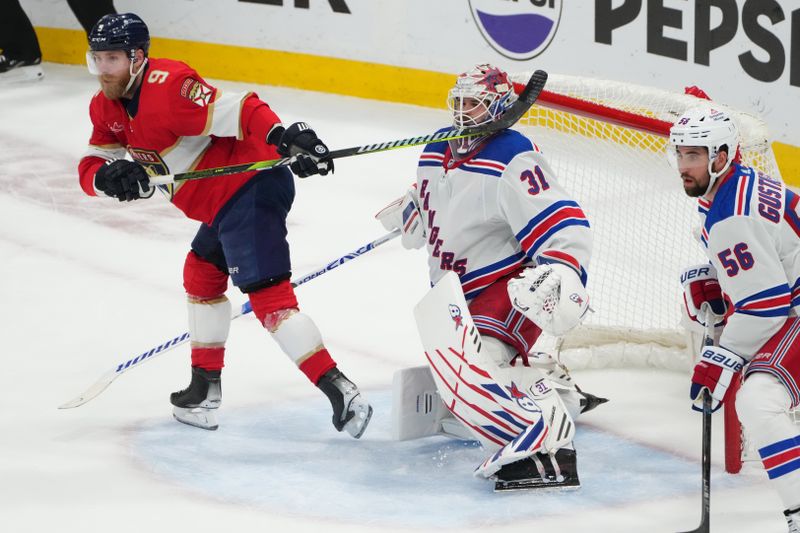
[{"xmin": 670, "ymin": 104, "xmax": 800, "ymax": 533}]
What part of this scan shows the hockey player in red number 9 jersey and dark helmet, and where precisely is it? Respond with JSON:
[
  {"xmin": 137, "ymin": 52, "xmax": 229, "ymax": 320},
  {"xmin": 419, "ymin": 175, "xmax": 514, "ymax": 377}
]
[{"xmin": 78, "ymin": 13, "xmax": 372, "ymax": 438}]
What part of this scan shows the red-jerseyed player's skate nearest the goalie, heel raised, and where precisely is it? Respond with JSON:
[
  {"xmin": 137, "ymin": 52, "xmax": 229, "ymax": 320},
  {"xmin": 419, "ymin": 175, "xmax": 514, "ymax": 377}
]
[{"xmin": 317, "ymin": 368, "xmax": 372, "ymax": 439}]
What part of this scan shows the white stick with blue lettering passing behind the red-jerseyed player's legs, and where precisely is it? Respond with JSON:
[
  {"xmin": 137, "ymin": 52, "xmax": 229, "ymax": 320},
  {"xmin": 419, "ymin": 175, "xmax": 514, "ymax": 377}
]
[{"xmin": 58, "ymin": 229, "xmax": 400, "ymax": 409}]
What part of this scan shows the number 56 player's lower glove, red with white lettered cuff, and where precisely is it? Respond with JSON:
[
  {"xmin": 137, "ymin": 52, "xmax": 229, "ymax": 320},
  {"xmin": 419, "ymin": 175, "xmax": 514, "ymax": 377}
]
[{"xmin": 689, "ymin": 346, "xmax": 746, "ymax": 412}]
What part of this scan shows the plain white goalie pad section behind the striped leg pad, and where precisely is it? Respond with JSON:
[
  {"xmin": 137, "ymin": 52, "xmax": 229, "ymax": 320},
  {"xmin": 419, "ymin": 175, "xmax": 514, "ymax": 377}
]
[{"xmin": 392, "ymin": 366, "xmax": 474, "ymax": 440}]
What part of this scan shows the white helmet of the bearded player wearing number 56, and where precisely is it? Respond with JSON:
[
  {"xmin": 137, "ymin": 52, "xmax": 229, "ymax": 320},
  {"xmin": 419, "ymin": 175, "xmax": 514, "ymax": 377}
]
[{"xmin": 669, "ymin": 106, "xmax": 739, "ymax": 194}]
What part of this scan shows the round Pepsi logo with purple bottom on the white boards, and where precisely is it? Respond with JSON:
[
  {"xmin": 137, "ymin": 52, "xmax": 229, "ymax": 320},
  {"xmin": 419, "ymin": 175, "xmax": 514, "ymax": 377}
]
[{"xmin": 469, "ymin": 0, "xmax": 562, "ymax": 61}]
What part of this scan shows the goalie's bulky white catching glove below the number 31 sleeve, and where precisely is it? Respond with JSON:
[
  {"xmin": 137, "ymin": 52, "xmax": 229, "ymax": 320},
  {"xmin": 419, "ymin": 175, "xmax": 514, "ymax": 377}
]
[{"xmin": 508, "ymin": 263, "xmax": 589, "ymax": 336}]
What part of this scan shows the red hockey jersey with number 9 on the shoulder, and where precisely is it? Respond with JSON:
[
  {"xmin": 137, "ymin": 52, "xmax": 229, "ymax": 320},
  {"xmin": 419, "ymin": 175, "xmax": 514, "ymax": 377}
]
[{"xmin": 78, "ymin": 59, "xmax": 280, "ymax": 224}]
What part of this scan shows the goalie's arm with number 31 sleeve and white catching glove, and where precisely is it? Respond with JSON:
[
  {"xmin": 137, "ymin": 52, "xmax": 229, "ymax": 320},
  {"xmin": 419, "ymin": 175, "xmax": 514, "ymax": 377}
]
[{"xmin": 497, "ymin": 150, "xmax": 592, "ymax": 335}]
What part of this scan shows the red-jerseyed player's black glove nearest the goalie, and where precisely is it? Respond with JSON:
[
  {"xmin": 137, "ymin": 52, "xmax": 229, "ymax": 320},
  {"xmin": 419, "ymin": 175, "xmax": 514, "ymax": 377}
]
[{"xmin": 267, "ymin": 122, "xmax": 333, "ymax": 178}]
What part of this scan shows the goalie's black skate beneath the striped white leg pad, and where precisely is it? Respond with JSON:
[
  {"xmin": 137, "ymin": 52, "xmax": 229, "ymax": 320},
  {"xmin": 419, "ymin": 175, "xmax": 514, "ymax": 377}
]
[{"xmin": 494, "ymin": 448, "xmax": 581, "ymax": 492}]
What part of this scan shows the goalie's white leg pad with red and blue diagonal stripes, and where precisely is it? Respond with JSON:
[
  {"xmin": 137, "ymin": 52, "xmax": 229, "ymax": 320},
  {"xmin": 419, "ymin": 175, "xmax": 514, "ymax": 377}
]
[{"xmin": 414, "ymin": 273, "xmax": 575, "ymax": 477}]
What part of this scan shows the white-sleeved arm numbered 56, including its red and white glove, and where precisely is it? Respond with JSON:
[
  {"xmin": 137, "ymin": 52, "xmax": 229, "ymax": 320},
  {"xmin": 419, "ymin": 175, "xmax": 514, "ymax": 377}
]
[{"xmin": 689, "ymin": 217, "xmax": 791, "ymax": 411}]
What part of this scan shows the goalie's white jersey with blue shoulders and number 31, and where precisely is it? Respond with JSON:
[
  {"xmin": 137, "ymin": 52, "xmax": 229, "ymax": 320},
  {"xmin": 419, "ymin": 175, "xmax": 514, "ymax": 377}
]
[{"xmin": 417, "ymin": 130, "xmax": 592, "ymax": 300}]
